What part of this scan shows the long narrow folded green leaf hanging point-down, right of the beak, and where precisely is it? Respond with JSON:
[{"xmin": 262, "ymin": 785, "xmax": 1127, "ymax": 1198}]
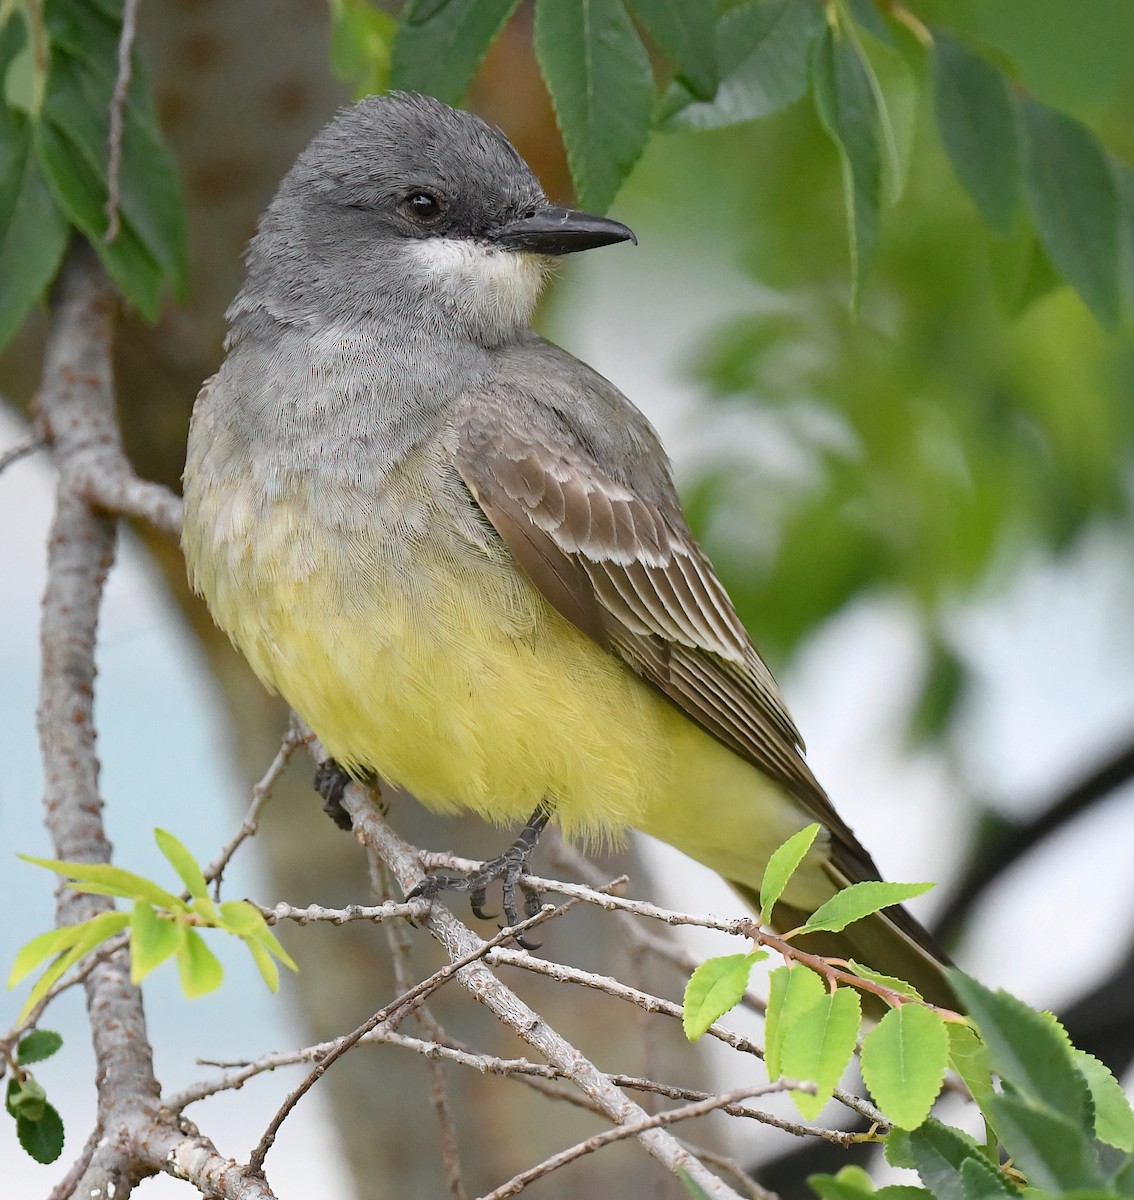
[{"xmin": 811, "ymin": 14, "xmax": 882, "ymax": 302}]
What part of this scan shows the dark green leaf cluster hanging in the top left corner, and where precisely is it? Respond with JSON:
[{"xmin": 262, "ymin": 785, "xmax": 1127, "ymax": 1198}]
[{"xmin": 0, "ymin": 0, "xmax": 188, "ymax": 347}]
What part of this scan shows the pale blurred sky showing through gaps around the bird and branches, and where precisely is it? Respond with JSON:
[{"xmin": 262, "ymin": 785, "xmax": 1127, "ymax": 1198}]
[{"xmin": 0, "ymin": 187, "xmax": 1134, "ymax": 1200}]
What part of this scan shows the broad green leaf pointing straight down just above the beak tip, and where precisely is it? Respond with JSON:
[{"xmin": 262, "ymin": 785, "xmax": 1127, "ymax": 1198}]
[{"xmin": 535, "ymin": 0, "xmax": 654, "ymax": 212}]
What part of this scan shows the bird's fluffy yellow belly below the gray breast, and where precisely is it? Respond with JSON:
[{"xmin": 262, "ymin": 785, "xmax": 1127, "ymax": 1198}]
[{"xmin": 191, "ymin": 484, "xmax": 830, "ymax": 904}]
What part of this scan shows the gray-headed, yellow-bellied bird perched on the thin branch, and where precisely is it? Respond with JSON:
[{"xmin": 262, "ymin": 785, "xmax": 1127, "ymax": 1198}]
[{"xmin": 182, "ymin": 92, "xmax": 955, "ymax": 1006}]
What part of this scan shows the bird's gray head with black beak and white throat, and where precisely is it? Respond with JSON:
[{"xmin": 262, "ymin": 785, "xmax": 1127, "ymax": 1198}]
[{"xmin": 229, "ymin": 92, "xmax": 634, "ymax": 344}]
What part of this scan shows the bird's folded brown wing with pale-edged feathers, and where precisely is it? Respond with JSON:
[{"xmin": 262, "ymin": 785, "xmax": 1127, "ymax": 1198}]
[{"xmin": 456, "ymin": 403, "xmax": 877, "ymax": 878}]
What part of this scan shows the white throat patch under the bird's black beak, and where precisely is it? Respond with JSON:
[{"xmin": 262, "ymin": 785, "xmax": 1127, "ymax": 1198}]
[{"xmin": 413, "ymin": 238, "xmax": 550, "ymax": 338}]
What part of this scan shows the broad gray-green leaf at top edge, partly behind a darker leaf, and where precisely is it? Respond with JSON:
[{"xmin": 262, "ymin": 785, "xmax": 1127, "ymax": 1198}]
[{"xmin": 659, "ymin": 0, "xmax": 823, "ymax": 130}]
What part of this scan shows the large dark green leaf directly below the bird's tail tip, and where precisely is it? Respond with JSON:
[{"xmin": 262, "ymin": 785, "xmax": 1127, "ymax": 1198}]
[{"xmin": 949, "ymin": 970, "xmax": 1090, "ymax": 1128}]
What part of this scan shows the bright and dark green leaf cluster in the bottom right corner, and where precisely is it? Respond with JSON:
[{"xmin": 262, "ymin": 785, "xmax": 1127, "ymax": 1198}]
[{"xmin": 684, "ymin": 827, "xmax": 1134, "ymax": 1200}]
